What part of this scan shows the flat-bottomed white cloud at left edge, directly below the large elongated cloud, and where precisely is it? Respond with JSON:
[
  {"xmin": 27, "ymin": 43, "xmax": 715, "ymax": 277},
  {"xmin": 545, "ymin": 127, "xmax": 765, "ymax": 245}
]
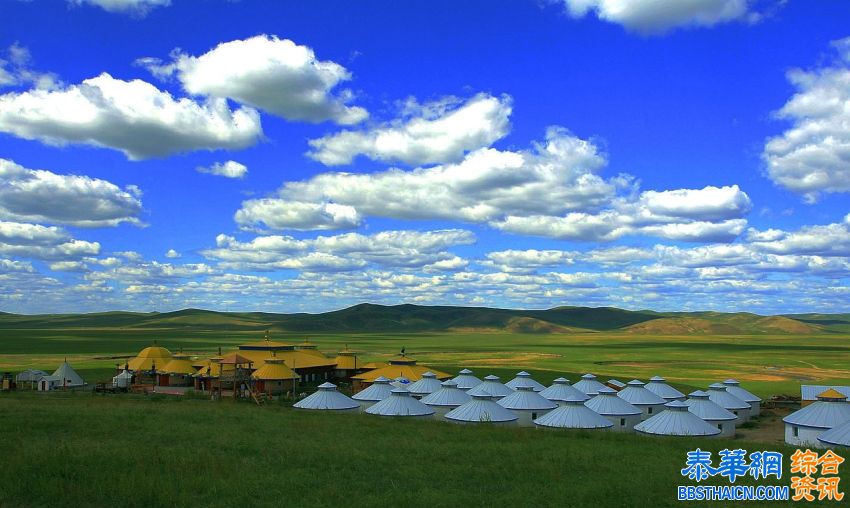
[{"xmin": 0, "ymin": 158, "xmax": 142, "ymax": 227}]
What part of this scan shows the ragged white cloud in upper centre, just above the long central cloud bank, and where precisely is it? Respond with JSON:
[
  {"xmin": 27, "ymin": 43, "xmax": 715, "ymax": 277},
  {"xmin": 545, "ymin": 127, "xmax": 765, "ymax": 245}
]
[{"xmin": 307, "ymin": 93, "xmax": 512, "ymax": 166}]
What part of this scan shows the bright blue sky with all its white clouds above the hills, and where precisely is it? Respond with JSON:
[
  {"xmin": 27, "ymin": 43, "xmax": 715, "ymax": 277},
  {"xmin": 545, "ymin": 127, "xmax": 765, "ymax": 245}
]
[{"xmin": 0, "ymin": 0, "xmax": 850, "ymax": 313}]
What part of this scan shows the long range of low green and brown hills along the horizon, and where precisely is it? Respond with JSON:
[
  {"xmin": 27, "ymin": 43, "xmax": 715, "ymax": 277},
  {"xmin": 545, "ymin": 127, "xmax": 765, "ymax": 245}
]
[{"xmin": 0, "ymin": 303, "xmax": 850, "ymax": 335}]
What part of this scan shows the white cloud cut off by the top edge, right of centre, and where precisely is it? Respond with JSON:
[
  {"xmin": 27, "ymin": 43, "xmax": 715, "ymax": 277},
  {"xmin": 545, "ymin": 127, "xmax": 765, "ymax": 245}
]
[{"xmin": 560, "ymin": 0, "xmax": 757, "ymax": 33}]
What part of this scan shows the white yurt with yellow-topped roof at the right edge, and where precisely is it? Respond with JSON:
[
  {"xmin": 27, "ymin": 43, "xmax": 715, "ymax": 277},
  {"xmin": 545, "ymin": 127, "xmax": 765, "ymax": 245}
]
[{"xmin": 782, "ymin": 389, "xmax": 850, "ymax": 446}]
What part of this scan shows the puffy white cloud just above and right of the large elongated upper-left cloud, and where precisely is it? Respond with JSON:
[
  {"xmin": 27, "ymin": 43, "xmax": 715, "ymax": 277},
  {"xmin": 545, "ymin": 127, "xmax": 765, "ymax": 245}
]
[{"xmin": 140, "ymin": 35, "xmax": 369, "ymax": 125}]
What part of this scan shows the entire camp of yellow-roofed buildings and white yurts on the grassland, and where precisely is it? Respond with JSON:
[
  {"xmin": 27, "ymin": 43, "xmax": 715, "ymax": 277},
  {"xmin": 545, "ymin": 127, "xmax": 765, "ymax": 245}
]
[{"xmin": 13, "ymin": 337, "xmax": 850, "ymax": 446}]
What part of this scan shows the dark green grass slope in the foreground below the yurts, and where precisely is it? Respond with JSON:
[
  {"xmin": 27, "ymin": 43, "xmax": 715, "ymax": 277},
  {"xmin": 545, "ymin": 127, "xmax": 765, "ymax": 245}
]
[{"xmin": 0, "ymin": 393, "xmax": 791, "ymax": 507}]
